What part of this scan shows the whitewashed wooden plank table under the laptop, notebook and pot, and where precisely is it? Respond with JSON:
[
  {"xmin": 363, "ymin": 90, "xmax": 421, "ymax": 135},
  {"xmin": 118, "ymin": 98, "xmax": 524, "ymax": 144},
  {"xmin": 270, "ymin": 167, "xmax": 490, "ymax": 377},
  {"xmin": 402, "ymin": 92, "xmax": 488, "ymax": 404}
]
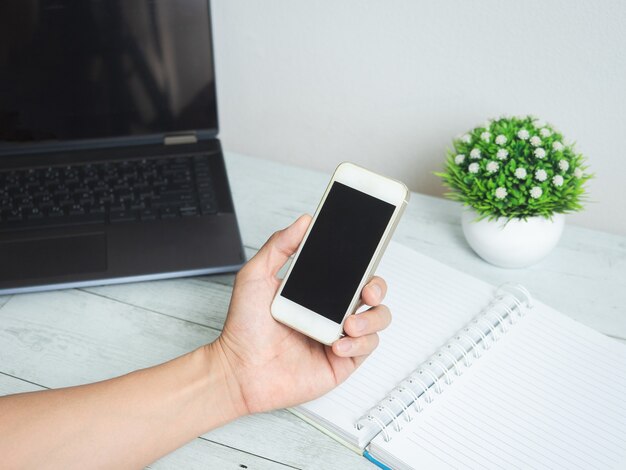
[{"xmin": 0, "ymin": 153, "xmax": 626, "ymax": 469}]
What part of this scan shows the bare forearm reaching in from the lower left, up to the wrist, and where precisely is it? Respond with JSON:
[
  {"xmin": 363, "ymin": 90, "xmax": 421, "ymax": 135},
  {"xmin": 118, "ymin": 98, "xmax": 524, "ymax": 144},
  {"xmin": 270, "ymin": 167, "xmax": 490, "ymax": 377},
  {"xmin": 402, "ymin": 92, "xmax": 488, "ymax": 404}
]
[{"xmin": 0, "ymin": 345, "xmax": 245, "ymax": 468}]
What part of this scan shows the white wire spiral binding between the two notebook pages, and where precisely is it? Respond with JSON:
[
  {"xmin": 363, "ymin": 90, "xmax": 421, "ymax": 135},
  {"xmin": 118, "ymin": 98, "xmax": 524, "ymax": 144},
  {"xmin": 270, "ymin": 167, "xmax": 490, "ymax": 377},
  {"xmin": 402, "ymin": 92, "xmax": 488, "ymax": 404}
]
[{"xmin": 355, "ymin": 283, "xmax": 533, "ymax": 442}]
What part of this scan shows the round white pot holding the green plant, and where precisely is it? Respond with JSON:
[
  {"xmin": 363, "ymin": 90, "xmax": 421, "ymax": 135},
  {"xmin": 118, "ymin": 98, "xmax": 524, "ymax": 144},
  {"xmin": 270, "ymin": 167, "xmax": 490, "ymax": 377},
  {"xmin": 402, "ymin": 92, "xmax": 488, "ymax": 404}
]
[{"xmin": 462, "ymin": 210, "xmax": 565, "ymax": 268}]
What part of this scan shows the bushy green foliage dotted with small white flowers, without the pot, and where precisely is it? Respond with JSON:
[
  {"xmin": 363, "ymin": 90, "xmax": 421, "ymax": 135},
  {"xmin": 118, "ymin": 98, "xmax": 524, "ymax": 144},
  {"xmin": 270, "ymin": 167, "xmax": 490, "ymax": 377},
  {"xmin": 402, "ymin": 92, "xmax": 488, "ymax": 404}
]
[{"xmin": 436, "ymin": 116, "xmax": 592, "ymax": 220}]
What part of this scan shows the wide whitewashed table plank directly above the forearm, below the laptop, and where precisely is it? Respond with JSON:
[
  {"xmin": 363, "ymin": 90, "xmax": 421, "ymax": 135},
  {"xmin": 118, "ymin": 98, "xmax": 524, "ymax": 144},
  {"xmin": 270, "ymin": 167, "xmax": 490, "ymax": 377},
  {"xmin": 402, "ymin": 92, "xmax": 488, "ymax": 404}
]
[{"xmin": 0, "ymin": 290, "xmax": 218, "ymax": 388}]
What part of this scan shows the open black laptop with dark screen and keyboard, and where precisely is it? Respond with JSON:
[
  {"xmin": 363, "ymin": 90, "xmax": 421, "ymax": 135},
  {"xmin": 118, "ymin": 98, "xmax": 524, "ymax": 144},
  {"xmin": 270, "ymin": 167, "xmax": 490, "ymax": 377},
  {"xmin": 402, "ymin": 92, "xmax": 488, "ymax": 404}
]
[{"xmin": 0, "ymin": 0, "xmax": 245, "ymax": 294}]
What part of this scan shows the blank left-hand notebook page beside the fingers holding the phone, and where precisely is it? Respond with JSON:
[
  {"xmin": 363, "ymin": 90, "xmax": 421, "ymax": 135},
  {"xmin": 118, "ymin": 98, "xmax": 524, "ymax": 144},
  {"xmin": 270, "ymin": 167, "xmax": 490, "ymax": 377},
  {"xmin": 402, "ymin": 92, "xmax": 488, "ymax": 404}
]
[{"xmin": 300, "ymin": 242, "xmax": 495, "ymax": 445}]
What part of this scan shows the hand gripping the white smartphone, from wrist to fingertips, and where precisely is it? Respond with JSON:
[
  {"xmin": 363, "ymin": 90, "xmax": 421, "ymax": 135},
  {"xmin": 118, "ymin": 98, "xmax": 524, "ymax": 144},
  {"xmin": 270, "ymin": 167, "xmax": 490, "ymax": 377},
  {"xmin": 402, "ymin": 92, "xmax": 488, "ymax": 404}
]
[{"xmin": 208, "ymin": 215, "xmax": 391, "ymax": 413}]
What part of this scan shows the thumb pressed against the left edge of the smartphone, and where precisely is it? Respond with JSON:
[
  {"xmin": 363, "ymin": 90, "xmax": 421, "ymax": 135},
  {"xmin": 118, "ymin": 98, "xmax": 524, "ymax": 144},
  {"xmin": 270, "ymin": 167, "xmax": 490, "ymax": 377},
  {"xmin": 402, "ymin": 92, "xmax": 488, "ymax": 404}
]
[{"xmin": 248, "ymin": 214, "xmax": 311, "ymax": 276}]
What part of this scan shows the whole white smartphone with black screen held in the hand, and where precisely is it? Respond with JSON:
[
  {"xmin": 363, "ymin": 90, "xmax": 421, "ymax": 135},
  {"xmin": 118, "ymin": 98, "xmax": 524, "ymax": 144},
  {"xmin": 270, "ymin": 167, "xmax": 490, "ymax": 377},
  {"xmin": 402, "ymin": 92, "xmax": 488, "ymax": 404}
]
[{"xmin": 271, "ymin": 163, "xmax": 410, "ymax": 345}]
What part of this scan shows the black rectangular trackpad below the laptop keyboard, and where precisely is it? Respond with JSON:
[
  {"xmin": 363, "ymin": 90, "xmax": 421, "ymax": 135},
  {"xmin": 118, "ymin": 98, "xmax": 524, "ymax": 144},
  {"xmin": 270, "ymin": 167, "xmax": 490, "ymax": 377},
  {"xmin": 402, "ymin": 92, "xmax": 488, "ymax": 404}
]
[{"xmin": 0, "ymin": 233, "xmax": 107, "ymax": 281}]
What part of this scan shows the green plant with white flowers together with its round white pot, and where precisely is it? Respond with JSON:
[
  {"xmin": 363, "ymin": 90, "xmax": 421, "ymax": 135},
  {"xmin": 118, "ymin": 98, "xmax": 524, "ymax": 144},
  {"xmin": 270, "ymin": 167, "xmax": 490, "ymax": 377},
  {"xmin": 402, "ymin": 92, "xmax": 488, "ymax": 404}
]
[{"xmin": 436, "ymin": 116, "xmax": 592, "ymax": 268}]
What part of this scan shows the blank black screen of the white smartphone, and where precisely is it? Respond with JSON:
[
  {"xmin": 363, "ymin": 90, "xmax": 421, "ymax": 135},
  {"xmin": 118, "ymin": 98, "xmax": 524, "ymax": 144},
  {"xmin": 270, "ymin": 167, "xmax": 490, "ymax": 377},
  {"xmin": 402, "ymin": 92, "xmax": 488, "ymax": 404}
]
[{"xmin": 281, "ymin": 182, "xmax": 395, "ymax": 323}]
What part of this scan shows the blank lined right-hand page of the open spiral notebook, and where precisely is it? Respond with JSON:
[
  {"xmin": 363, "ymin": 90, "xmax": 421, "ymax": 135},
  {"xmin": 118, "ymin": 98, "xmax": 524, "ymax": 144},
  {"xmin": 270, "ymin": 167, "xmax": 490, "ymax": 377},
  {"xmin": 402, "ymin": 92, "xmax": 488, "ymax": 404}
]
[{"xmin": 370, "ymin": 303, "xmax": 626, "ymax": 469}]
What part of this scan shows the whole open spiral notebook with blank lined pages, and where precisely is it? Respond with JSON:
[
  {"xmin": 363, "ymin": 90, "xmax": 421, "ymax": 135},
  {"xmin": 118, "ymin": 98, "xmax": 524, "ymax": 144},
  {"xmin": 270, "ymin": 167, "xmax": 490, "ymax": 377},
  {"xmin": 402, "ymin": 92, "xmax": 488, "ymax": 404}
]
[{"xmin": 292, "ymin": 243, "xmax": 626, "ymax": 469}]
